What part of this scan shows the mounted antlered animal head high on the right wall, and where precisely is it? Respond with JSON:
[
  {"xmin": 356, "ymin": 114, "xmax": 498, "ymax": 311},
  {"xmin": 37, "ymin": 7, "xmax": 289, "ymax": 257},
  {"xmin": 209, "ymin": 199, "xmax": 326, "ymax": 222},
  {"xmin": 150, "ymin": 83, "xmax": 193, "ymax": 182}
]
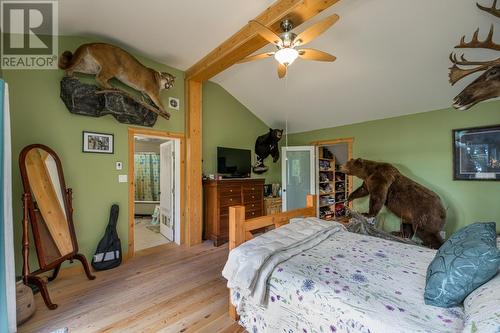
[{"xmin": 449, "ymin": 0, "xmax": 500, "ymax": 111}]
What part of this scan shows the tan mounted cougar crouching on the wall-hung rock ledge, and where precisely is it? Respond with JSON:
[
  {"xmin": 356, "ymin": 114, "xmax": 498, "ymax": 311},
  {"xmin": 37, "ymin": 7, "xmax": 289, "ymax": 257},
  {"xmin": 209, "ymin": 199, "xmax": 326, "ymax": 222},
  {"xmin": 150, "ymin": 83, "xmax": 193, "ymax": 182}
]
[{"xmin": 59, "ymin": 43, "xmax": 175, "ymax": 119}]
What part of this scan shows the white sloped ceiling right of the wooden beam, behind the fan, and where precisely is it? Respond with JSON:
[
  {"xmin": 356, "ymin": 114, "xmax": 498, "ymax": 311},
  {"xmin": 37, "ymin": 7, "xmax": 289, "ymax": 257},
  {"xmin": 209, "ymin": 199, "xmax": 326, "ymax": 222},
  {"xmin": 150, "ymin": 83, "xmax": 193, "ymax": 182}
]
[{"xmin": 215, "ymin": 0, "xmax": 500, "ymax": 132}]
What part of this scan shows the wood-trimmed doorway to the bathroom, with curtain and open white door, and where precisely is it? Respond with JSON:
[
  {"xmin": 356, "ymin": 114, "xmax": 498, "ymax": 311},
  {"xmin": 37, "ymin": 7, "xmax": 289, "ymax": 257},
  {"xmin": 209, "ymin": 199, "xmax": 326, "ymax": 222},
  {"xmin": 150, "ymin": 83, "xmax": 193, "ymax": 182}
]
[{"xmin": 128, "ymin": 128, "xmax": 184, "ymax": 257}]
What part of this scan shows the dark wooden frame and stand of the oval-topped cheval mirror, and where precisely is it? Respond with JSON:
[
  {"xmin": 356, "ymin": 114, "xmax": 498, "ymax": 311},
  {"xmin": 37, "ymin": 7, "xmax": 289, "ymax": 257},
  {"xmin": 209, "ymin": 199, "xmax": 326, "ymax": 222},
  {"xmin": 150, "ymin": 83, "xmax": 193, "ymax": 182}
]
[{"xmin": 19, "ymin": 144, "xmax": 95, "ymax": 310}]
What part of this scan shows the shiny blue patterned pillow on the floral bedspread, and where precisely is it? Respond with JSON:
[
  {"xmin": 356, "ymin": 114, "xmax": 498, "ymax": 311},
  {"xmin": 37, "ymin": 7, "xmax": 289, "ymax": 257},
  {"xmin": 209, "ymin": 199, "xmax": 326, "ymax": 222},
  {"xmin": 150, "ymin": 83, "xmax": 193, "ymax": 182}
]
[{"xmin": 424, "ymin": 222, "xmax": 500, "ymax": 308}]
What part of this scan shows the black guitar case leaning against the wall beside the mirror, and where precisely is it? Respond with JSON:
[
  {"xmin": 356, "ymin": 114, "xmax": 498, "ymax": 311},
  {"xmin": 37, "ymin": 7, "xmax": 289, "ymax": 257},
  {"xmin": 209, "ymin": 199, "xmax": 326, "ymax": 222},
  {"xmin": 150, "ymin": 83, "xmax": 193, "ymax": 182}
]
[{"xmin": 92, "ymin": 204, "xmax": 122, "ymax": 271}]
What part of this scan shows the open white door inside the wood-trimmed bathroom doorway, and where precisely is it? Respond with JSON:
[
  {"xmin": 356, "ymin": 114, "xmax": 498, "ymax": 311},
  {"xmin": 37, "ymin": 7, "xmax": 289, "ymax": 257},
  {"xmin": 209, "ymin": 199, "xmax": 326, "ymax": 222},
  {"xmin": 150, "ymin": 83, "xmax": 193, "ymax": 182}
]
[{"xmin": 160, "ymin": 141, "xmax": 175, "ymax": 241}]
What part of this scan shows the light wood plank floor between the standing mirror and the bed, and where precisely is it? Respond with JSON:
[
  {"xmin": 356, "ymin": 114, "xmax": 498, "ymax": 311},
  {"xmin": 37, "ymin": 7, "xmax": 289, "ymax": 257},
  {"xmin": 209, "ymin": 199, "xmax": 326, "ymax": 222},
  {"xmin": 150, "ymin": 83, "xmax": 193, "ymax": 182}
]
[{"xmin": 19, "ymin": 242, "xmax": 245, "ymax": 333}]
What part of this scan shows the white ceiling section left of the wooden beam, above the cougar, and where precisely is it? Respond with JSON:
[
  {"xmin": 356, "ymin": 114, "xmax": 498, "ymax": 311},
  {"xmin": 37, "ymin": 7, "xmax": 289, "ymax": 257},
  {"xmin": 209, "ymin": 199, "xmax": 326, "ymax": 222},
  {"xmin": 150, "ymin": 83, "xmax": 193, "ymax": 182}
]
[{"xmin": 59, "ymin": 0, "xmax": 274, "ymax": 70}]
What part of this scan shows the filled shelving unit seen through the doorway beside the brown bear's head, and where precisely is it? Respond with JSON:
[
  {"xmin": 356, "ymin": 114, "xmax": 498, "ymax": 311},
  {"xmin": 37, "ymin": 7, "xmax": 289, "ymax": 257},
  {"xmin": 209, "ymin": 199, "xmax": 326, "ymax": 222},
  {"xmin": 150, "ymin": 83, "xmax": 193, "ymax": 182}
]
[{"xmin": 317, "ymin": 146, "xmax": 350, "ymax": 220}]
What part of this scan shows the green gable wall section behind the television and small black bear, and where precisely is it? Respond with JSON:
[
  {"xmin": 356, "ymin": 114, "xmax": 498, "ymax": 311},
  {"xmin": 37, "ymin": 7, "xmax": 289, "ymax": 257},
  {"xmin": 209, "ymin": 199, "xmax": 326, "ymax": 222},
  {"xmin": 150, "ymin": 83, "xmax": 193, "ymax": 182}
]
[{"xmin": 203, "ymin": 82, "xmax": 281, "ymax": 183}]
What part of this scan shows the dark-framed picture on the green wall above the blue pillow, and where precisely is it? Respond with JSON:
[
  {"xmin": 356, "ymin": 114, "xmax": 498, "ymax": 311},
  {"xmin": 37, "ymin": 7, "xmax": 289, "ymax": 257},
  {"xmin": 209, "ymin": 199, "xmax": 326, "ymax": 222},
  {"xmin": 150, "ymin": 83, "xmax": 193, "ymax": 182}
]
[{"xmin": 453, "ymin": 125, "xmax": 500, "ymax": 180}]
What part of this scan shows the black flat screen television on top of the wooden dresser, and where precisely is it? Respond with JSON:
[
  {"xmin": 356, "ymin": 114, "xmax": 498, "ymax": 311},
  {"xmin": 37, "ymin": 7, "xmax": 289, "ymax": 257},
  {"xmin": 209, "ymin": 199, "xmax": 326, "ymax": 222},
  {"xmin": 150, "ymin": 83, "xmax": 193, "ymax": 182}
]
[{"xmin": 217, "ymin": 147, "xmax": 252, "ymax": 178}]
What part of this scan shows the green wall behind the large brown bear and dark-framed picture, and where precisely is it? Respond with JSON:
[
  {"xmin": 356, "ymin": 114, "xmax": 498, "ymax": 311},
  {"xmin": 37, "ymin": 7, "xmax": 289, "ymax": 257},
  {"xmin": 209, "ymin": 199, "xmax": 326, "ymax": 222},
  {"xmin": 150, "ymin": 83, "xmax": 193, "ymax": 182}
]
[{"xmin": 289, "ymin": 101, "xmax": 500, "ymax": 236}]
